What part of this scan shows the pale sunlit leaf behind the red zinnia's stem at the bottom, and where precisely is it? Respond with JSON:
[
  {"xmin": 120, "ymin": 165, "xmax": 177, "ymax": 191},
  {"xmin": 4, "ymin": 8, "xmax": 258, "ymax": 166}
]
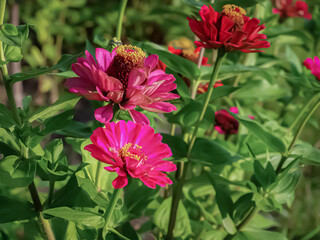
[{"xmin": 153, "ymin": 197, "xmax": 192, "ymax": 238}]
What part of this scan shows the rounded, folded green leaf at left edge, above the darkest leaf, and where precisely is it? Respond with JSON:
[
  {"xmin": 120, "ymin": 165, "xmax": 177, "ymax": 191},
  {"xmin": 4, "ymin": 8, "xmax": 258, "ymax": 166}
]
[{"xmin": 0, "ymin": 155, "xmax": 36, "ymax": 187}]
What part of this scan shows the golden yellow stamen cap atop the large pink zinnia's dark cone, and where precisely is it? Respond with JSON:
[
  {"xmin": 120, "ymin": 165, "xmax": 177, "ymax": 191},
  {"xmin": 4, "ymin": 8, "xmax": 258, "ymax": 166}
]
[{"xmin": 116, "ymin": 45, "xmax": 146, "ymax": 65}]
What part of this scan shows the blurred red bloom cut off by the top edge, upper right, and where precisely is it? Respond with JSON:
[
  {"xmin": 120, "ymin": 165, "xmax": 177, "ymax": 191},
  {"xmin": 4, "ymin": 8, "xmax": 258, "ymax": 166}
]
[{"xmin": 272, "ymin": 0, "xmax": 312, "ymax": 19}]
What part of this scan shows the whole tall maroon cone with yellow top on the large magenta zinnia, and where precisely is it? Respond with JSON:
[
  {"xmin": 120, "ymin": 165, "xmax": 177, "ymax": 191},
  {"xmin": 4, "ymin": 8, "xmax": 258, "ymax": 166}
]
[{"xmin": 107, "ymin": 45, "xmax": 146, "ymax": 87}]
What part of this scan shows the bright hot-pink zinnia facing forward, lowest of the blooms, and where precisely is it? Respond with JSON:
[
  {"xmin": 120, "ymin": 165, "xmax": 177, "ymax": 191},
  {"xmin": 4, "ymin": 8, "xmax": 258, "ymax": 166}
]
[{"xmin": 84, "ymin": 120, "xmax": 177, "ymax": 188}]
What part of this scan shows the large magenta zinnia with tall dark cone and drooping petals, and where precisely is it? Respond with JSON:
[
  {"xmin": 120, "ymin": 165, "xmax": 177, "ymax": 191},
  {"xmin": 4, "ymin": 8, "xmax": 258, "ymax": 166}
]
[{"xmin": 65, "ymin": 45, "xmax": 179, "ymax": 125}]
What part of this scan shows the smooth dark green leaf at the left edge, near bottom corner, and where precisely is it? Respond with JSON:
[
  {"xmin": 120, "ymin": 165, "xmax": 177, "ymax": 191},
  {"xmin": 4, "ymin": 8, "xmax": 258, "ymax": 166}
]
[{"xmin": 0, "ymin": 196, "xmax": 37, "ymax": 223}]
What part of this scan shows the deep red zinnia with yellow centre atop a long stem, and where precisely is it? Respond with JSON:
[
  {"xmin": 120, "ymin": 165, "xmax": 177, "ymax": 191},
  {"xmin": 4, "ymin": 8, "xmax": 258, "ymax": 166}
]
[{"xmin": 187, "ymin": 4, "xmax": 270, "ymax": 52}]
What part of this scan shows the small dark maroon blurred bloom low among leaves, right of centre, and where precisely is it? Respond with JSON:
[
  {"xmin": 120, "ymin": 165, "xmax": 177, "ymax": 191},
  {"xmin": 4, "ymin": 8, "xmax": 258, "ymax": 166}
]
[{"xmin": 214, "ymin": 107, "xmax": 239, "ymax": 135}]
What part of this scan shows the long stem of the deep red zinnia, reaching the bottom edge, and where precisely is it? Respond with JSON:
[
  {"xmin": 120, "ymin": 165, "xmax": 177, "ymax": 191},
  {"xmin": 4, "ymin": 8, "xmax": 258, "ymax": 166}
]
[{"xmin": 166, "ymin": 50, "xmax": 226, "ymax": 240}]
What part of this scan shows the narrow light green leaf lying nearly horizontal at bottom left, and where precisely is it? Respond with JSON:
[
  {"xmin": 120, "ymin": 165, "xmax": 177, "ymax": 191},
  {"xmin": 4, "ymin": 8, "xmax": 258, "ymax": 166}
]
[{"xmin": 43, "ymin": 207, "xmax": 104, "ymax": 228}]
